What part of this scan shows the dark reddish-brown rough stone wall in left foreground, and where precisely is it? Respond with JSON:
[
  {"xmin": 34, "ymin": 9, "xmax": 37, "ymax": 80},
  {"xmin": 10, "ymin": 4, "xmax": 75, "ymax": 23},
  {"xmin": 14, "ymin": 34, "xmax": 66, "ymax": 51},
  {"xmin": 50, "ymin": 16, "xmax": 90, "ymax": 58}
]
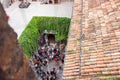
[{"xmin": 0, "ymin": 4, "xmax": 36, "ymax": 80}]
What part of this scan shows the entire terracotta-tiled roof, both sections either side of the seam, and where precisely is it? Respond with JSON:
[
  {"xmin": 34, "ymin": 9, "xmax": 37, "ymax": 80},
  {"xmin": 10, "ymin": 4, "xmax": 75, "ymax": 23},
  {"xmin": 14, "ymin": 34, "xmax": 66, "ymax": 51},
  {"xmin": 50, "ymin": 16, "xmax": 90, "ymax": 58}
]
[{"xmin": 64, "ymin": 0, "xmax": 120, "ymax": 78}]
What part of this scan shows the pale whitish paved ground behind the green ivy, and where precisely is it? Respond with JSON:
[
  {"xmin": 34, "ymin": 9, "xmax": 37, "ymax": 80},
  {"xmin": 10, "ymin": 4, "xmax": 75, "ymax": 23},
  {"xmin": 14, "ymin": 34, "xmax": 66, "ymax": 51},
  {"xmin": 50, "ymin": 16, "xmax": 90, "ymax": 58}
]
[{"xmin": 5, "ymin": 2, "xmax": 73, "ymax": 38}]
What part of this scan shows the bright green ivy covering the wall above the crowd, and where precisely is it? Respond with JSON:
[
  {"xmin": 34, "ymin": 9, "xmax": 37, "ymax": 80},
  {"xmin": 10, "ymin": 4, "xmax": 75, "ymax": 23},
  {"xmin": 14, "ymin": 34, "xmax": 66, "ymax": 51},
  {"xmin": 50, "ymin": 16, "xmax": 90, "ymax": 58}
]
[{"xmin": 18, "ymin": 16, "xmax": 70, "ymax": 58}]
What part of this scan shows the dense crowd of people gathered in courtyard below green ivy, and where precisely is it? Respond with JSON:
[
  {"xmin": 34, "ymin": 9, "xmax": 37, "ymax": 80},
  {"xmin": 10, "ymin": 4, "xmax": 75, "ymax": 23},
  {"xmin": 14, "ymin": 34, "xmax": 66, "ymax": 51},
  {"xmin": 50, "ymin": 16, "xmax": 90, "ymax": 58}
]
[{"xmin": 30, "ymin": 32, "xmax": 65, "ymax": 80}]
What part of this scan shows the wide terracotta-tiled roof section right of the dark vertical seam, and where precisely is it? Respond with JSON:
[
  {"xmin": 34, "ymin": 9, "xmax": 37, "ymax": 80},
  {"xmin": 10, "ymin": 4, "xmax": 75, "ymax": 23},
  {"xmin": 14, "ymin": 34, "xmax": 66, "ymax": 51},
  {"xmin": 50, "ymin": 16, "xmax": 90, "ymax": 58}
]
[{"xmin": 81, "ymin": 0, "xmax": 120, "ymax": 75}]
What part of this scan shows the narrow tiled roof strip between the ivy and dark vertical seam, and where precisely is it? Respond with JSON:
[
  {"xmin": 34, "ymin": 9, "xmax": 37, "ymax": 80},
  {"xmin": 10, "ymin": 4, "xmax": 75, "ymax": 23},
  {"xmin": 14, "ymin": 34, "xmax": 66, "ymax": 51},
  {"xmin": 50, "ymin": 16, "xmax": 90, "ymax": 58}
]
[{"xmin": 64, "ymin": 0, "xmax": 81, "ymax": 79}]
